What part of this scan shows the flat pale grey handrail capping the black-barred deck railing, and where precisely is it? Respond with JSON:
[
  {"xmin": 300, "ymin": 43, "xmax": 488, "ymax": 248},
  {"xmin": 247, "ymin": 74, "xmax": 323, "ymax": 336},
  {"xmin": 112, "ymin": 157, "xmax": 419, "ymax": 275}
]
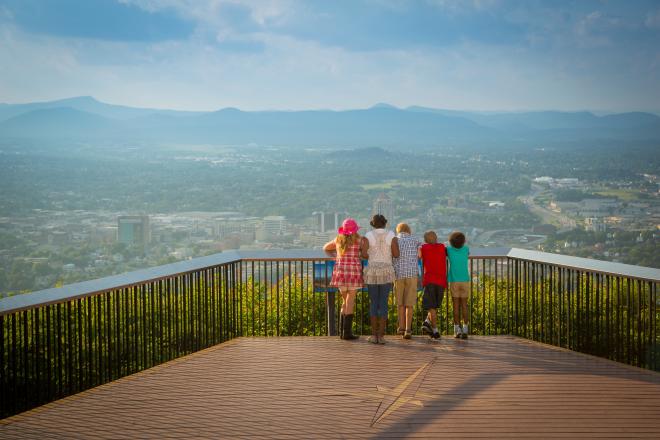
[{"xmin": 0, "ymin": 248, "xmax": 660, "ymax": 316}]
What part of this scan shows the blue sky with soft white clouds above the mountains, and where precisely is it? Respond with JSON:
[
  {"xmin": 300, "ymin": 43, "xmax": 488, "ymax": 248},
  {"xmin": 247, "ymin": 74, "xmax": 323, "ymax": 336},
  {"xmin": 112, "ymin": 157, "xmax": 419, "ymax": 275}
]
[{"xmin": 0, "ymin": 0, "xmax": 660, "ymax": 112}]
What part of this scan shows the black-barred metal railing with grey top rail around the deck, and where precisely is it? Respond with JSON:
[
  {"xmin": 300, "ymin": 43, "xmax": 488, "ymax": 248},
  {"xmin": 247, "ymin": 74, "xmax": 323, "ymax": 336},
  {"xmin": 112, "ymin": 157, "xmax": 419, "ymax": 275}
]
[{"xmin": 0, "ymin": 249, "xmax": 660, "ymax": 417}]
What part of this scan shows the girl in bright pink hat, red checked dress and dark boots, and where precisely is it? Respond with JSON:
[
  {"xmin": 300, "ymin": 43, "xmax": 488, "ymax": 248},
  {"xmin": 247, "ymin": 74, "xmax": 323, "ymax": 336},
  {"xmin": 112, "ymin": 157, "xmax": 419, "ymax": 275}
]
[{"xmin": 323, "ymin": 218, "xmax": 366, "ymax": 340}]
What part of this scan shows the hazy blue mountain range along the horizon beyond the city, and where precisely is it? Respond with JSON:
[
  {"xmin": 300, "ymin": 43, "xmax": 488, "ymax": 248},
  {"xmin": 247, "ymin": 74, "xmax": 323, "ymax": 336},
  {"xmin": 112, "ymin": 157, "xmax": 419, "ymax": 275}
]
[{"xmin": 0, "ymin": 96, "xmax": 660, "ymax": 147}]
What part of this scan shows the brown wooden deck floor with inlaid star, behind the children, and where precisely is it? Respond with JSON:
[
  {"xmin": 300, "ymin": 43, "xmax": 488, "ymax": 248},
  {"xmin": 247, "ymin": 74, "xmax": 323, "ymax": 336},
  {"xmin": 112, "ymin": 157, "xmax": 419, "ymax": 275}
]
[{"xmin": 0, "ymin": 337, "xmax": 660, "ymax": 439}]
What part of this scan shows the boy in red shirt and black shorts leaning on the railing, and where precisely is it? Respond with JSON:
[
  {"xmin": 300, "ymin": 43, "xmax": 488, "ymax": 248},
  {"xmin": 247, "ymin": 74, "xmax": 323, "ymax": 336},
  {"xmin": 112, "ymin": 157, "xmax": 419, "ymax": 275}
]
[{"xmin": 419, "ymin": 231, "xmax": 447, "ymax": 339}]
